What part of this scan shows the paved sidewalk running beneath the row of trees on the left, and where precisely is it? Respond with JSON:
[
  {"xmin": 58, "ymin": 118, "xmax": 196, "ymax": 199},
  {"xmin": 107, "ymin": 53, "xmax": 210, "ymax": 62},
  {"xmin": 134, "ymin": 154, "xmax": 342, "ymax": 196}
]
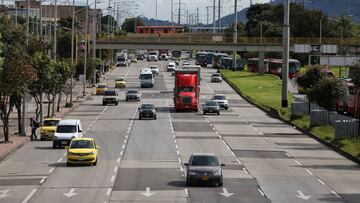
[{"xmin": 0, "ymin": 66, "xmax": 114, "ymax": 161}]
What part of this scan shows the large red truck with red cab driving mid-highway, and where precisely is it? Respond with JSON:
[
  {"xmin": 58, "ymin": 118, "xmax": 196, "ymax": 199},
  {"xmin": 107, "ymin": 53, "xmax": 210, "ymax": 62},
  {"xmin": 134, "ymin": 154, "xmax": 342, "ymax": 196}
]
[{"xmin": 174, "ymin": 67, "xmax": 200, "ymax": 112}]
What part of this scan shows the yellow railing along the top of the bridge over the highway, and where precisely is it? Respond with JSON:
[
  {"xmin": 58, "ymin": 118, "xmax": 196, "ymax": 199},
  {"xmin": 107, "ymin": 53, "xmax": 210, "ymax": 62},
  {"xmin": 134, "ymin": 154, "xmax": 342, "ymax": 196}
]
[{"xmin": 97, "ymin": 33, "xmax": 360, "ymax": 46}]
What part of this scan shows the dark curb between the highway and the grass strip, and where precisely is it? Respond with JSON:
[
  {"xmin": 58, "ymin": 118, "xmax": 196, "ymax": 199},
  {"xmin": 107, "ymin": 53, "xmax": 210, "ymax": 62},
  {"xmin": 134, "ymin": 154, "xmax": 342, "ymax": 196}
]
[{"xmin": 221, "ymin": 73, "xmax": 360, "ymax": 165}]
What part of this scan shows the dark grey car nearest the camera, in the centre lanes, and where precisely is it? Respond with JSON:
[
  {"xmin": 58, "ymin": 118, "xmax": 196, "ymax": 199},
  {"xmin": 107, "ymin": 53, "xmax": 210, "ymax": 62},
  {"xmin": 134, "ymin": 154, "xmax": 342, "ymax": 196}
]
[{"xmin": 184, "ymin": 153, "xmax": 225, "ymax": 186}]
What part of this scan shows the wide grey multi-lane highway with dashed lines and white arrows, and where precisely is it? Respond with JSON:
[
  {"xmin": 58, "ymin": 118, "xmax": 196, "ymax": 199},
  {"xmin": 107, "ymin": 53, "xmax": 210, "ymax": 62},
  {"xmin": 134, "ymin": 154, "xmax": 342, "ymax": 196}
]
[{"xmin": 0, "ymin": 61, "xmax": 360, "ymax": 203}]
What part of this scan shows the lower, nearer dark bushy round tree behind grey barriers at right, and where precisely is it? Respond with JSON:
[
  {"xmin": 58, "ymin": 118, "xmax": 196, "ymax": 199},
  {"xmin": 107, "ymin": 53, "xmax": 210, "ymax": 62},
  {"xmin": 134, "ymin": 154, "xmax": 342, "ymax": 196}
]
[{"xmin": 306, "ymin": 77, "xmax": 347, "ymax": 110}]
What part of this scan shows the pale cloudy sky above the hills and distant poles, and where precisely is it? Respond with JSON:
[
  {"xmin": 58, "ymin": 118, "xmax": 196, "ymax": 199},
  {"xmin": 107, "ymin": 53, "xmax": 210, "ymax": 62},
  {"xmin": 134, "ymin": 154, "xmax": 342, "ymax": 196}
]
[{"xmin": 90, "ymin": 0, "xmax": 270, "ymax": 23}]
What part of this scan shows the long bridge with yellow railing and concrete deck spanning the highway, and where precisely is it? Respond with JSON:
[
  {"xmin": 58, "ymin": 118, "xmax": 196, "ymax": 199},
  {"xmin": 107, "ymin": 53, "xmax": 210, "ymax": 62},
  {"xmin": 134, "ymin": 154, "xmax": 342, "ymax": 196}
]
[{"xmin": 96, "ymin": 33, "xmax": 360, "ymax": 52}]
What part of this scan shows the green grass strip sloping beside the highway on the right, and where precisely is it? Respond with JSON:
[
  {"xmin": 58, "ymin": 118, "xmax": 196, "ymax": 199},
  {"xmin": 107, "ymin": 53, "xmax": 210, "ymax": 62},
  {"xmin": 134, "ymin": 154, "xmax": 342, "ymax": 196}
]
[{"xmin": 221, "ymin": 70, "xmax": 360, "ymax": 158}]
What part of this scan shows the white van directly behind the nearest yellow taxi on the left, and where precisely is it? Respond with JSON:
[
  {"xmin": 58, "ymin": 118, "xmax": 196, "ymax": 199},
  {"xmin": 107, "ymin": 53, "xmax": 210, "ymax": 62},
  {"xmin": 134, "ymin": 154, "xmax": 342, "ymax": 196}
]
[{"xmin": 53, "ymin": 120, "xmax": 83, "ymax": 148}]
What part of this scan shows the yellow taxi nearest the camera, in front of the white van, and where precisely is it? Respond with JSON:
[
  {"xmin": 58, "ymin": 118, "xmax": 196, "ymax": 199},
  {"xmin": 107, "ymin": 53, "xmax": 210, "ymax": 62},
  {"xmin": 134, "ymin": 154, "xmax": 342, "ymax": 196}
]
[{"xmin": 65, "ymin": 138, "xmax": 100, "ymax": 166}]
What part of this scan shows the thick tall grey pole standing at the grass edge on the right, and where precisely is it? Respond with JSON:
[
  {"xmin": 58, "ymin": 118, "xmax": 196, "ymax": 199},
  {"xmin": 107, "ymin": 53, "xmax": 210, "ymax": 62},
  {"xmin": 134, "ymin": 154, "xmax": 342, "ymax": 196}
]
[{"xmin": 281, "ymin": 0, "xmax": 290, "ymax": 108}]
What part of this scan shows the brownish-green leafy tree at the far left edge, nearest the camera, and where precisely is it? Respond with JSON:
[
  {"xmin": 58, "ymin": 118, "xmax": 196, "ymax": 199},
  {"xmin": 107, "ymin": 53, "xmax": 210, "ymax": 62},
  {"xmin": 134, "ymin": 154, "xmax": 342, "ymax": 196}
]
[{"xmin": 0, "ymin": 15, "xmax": 36, "ymax": 142}]
